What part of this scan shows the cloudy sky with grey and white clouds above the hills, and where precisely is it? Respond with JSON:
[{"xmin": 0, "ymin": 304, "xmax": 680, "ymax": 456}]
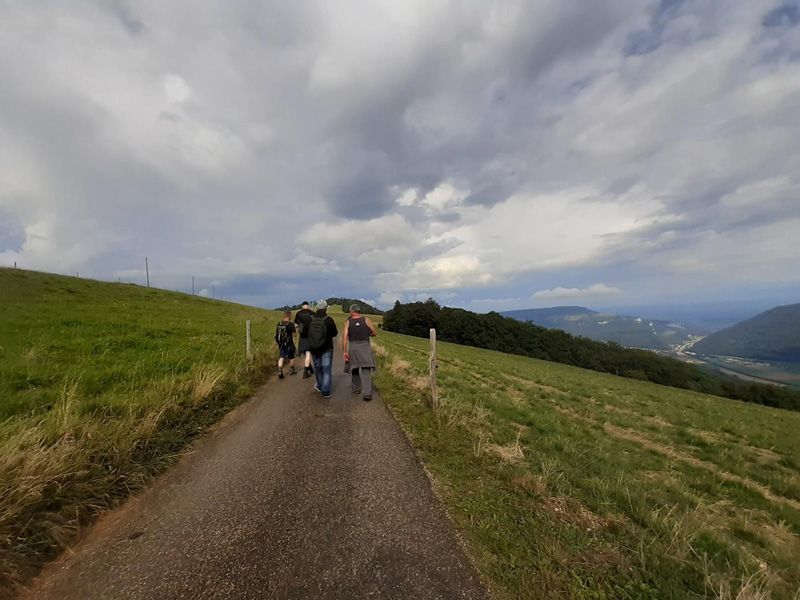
[{"xmin": 0, "ymin": 0, "xmax": 800, "ymax": 311}]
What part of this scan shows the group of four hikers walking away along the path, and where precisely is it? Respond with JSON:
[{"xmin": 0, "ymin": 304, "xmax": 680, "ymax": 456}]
[{"xmin": 275, "ymin": 300, "xmax": 377, "ymax": 401}]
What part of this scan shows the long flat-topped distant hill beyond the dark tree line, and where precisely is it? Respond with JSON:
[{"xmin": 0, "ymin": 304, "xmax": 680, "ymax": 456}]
[{"xmin": 501, "ymin": 306, "xmax": 705, "ymax": 350}]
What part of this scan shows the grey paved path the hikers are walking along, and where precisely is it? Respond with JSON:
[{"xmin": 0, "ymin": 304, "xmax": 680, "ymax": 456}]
[{"xmin": 25, "ymin": 350, "xmax": 486, "ymax": 600}]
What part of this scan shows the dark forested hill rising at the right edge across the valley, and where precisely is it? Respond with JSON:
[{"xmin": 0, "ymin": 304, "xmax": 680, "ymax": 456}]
[{"xmin": 691, "ymin": 304, "xmax": 800, "ymax": 363}]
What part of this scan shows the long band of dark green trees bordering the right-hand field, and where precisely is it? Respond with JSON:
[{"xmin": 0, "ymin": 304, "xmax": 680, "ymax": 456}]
[{"xmin": 383, "ymin": 299, "xmax": 800, "ymax": 411}]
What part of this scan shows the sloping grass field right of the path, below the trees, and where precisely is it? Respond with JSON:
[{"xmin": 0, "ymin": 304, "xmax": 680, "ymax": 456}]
[{"xmin": 377, "ymin": 332, "xmax": 800, "ymax": 600}]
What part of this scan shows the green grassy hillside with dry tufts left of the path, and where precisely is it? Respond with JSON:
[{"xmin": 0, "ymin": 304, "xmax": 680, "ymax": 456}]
[{"xmin": 0, "ymin": 269, "xmax": 278, "ymax": 597}]
